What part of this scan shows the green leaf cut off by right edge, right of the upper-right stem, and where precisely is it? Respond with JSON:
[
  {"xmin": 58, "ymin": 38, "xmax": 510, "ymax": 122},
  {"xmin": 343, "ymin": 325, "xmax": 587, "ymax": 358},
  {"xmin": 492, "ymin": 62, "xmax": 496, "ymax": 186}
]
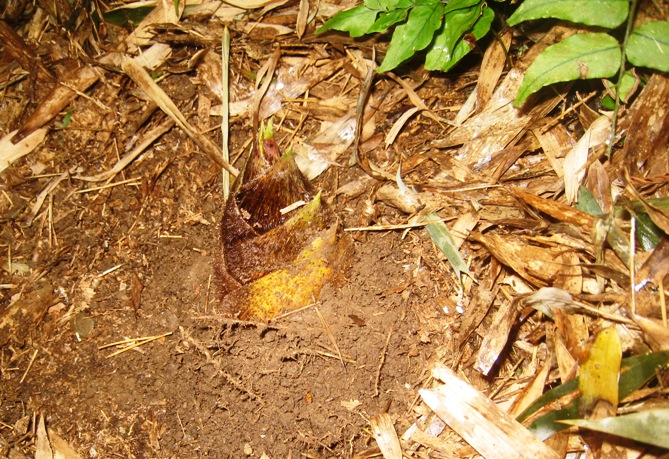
[{"xmin": 627, "ymin": 21, "xmax": 669, "ymax": 72}]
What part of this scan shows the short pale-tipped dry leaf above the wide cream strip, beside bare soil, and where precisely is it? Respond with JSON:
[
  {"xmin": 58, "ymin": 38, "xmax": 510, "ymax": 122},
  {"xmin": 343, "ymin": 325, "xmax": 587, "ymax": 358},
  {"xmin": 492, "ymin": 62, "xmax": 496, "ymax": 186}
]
[{"xmin": 474, "ymin": 302, "xmax": 518, "ymax": 375}]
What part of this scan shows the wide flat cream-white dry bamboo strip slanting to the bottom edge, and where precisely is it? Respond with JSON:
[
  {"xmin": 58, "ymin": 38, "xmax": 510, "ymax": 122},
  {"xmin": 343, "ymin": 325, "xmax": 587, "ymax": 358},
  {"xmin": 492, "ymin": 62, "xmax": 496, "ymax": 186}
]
[{"xmin": 419, "ymin": 365, "xmax": 558, "ymax": 459}]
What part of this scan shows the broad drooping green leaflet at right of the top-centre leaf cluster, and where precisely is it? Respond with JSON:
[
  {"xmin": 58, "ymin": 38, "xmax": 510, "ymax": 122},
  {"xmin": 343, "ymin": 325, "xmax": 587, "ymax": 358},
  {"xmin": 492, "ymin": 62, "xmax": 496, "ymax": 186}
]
[{"xmin": 425, "ymin": 4, "xmax": 481, "ymax": 70}]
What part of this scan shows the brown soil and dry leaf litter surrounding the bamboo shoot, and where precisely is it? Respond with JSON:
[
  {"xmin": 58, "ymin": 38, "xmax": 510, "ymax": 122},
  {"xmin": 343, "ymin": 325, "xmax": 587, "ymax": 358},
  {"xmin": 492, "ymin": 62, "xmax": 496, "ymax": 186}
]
[{"xmin": 0, "ymin": 1, "xmax": 669, "ymax": 459}]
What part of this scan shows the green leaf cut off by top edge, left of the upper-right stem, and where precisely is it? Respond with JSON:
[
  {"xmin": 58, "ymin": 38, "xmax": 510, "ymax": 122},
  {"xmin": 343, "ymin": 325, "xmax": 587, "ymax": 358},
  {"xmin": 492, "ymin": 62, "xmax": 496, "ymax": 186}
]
[{"xmin": 507, "ymin": 0, "xmax": 629, "ymax": 29}]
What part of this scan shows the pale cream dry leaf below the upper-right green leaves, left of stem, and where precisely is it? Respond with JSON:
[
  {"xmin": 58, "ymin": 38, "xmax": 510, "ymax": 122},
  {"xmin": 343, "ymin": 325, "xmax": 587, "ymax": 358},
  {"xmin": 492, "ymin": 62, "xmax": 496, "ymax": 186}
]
[{"xmin": 562, "ymin": 115, "xmax": 611, "ymax": 204}]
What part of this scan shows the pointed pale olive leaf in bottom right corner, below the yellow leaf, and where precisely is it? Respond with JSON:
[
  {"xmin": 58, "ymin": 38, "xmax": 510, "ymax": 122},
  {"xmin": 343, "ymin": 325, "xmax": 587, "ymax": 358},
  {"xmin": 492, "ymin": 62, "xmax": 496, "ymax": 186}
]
[{"xmin": 562, "ymin": 408, "xmax": 669, "ymax": 448}]
